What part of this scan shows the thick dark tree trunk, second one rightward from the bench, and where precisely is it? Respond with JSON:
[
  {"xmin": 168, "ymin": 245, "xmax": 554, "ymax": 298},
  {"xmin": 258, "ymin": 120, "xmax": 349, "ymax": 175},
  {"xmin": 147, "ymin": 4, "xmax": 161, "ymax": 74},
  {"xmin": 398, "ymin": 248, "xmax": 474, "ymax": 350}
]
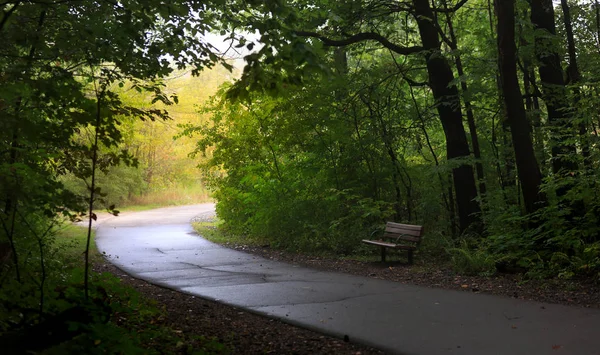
[{"xmin": 495, "ymin": 0, "xmax": 545, "ymax": 213}]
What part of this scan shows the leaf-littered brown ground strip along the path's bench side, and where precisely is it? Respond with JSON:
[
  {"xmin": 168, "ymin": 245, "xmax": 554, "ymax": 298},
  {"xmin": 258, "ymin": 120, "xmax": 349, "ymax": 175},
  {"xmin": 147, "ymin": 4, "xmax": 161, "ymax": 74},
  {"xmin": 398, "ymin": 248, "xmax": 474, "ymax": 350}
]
[{"xmin": 220, "ymin": 244, "xmax": 600, "ymax": 308}]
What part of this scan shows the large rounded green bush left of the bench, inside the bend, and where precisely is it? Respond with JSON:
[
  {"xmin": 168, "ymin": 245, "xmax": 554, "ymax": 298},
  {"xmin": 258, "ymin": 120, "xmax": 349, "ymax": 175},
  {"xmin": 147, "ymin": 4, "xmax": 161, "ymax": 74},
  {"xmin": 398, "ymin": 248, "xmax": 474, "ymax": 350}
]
[{"xmin": 186, "ymin": 65, "xmax": 441, "ymax": 253}]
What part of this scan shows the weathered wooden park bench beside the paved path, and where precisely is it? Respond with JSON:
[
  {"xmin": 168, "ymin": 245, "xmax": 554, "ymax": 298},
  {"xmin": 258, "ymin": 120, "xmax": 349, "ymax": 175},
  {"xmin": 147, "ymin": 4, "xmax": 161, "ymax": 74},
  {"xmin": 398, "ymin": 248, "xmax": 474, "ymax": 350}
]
[{"xmin": 363, "ymin": 222, "xmax": 423, "ymax": 264}]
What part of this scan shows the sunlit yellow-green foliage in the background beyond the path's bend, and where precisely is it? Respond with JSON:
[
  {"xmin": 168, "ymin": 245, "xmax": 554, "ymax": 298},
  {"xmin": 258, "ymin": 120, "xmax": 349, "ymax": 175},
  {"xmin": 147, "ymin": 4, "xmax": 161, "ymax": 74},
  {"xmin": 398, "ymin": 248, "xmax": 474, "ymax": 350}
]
[{"xmin": 59, "ymin": 67, "xmax": 235, "ymax": 208}]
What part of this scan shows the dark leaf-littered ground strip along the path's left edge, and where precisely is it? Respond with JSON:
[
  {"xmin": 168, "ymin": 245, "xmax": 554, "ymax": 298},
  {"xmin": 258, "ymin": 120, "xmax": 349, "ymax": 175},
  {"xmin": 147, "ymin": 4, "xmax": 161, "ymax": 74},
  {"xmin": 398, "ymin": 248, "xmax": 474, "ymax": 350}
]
[{"xmin": 94, "ymin": 260, "xmax": 383, "ymax": 355}]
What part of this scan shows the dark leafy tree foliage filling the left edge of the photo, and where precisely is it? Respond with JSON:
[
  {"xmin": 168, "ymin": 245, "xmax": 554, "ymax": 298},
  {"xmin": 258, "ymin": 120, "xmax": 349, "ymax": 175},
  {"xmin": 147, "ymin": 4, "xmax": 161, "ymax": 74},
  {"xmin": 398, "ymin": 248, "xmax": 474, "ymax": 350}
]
[{"xmin": 0, "ymin": 0, "xmax": 236, "ymax": 353}]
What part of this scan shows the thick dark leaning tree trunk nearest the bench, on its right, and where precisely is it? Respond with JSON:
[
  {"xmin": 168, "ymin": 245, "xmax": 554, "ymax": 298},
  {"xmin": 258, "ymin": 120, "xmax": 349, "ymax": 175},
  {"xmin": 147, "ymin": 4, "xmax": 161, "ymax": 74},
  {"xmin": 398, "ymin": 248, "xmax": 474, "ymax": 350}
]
[{"xmin": 413, "ymin": 0, "xmax": 482, "ymax": 232}]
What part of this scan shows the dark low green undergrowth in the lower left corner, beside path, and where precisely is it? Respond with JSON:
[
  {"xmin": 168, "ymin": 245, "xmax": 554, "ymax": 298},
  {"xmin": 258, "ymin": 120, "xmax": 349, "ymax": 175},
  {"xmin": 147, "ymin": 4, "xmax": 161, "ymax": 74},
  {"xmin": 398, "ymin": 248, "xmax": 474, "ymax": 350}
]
[{"xmin": 0, "ymin": 225, "xmax": 230, "ymax": 354}]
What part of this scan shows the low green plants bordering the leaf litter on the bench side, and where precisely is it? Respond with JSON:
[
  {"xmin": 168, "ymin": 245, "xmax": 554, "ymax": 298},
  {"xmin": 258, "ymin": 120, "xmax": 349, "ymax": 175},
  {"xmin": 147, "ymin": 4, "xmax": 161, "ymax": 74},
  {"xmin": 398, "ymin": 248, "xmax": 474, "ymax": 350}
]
[{"xmin": 193, "ymin": 214, "xmax": 600, "ymax": 280}]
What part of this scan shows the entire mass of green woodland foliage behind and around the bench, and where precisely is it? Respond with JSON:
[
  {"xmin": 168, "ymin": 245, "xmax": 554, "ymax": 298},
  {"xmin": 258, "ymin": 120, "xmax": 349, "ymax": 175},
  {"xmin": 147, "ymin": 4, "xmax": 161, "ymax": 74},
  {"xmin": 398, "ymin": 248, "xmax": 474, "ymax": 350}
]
[{"xmin": 183, "ymin": 0, "xmax": 600, "ymax": 276}]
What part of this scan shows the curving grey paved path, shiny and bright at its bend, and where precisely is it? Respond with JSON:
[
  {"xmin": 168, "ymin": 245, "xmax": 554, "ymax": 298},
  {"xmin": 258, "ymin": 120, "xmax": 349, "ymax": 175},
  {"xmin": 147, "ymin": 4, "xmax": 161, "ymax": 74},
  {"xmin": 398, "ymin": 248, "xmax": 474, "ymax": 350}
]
[{"xmin": 96, "ymin": 204, "xmax": 600, "ymax": 355}]
